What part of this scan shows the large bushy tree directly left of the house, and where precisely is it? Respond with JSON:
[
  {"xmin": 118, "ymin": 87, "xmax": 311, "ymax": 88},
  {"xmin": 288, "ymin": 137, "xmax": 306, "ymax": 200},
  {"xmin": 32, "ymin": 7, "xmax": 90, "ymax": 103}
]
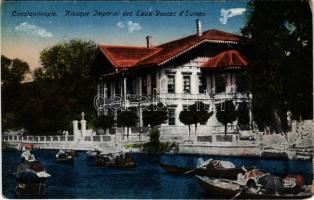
[{"xmin": 20, "ymin": 40, "xmax": 97, "ymax": 134}]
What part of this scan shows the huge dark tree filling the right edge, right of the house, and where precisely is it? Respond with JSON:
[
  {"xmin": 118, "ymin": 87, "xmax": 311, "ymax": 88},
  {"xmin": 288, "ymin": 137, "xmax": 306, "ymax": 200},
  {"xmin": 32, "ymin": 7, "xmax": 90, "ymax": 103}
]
[{"xmin": 242, "ymin": 1, "xmax": 313, "ymax": 130}]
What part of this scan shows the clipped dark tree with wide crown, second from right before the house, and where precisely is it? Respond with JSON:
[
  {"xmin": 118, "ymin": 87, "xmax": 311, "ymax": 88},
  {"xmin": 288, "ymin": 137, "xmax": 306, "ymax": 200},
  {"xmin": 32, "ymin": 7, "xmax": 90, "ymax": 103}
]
[{"xmin": 187, "ymin": 101, "xmax": 214, "ymax": 134}]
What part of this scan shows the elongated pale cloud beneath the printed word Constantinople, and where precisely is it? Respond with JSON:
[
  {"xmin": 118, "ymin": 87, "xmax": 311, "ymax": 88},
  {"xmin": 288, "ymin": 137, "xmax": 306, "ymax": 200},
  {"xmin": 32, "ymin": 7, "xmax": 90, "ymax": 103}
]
[{"xmin": 14, "ymin": 22, "xmax": 53, "ymax": 38}]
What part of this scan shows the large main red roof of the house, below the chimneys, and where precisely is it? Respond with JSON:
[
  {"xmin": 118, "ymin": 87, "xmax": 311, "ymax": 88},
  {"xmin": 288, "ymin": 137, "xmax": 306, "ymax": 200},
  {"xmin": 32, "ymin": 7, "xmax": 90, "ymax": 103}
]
[{"xmin": 100, "ymin": 29, "xmax": 244, "ymax": 68}]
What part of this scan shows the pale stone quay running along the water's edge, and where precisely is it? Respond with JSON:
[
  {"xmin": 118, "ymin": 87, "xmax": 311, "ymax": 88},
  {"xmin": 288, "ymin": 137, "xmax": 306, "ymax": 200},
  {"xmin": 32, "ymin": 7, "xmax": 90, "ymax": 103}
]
[{"xmin": 5, "ymin": 141, "xmax": 311, "ymax": 160}]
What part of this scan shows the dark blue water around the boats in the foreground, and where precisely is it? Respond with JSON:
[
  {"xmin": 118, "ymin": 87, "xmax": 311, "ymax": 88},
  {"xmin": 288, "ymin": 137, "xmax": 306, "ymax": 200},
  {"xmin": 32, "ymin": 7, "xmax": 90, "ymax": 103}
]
[{"xmin": 2, "ymin": 150, "xmax": 312, "ymax": 199}]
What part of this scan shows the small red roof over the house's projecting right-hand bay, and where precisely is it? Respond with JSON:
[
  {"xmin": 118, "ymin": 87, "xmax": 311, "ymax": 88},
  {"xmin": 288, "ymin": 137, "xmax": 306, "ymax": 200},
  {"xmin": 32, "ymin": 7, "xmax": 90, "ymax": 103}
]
[{"xmin": 202, "ymin": 50, "xmax": 248, "ymax": 69}]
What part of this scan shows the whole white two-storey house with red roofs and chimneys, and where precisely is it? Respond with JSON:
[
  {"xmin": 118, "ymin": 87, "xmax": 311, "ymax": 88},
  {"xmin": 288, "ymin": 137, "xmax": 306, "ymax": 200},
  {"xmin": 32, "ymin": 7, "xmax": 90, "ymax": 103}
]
[{"xmin": 90, "ymin": 20, "xmax": 252, "ymax": 134}]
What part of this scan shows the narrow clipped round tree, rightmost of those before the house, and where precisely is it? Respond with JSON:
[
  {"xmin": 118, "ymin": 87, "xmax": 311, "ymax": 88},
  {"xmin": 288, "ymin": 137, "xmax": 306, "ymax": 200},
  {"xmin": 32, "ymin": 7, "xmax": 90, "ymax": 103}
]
[{"xmin": 216, "ymin": 100, "xmax": 237, "ymax": 135}]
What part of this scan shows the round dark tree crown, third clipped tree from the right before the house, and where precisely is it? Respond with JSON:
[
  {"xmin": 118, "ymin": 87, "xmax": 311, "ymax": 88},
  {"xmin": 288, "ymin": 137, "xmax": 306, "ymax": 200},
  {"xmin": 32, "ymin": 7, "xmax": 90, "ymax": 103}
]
[{"xmin": 143, "ymin": 103, "xmax": 168, "ymax": 127}]
